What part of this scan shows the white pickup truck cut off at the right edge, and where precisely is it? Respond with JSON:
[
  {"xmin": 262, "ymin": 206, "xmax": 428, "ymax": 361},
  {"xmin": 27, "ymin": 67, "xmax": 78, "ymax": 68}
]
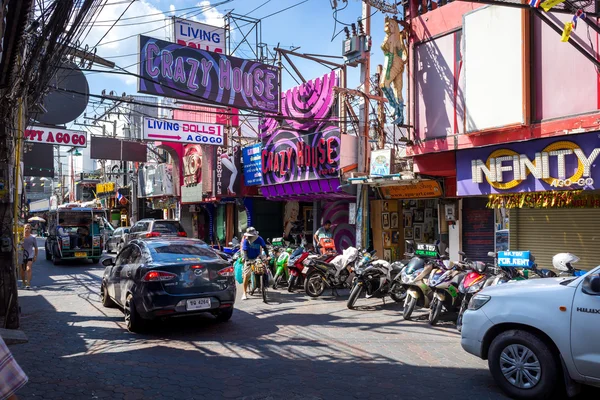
[{"xmin": 461, "ymin": 267, "xmax": 600, "ymax": 399}]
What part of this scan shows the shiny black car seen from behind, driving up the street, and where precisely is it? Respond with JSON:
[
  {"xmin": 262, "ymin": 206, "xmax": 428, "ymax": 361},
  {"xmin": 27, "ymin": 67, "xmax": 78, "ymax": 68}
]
[{"xmin": 100, "ymin": 238, "xmax": 236, "ymax": 332}]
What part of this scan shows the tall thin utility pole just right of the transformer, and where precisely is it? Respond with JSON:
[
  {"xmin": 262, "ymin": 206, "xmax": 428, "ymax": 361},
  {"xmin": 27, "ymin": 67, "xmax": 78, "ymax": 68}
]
[{"xmin": 356, "ymin": 1, "xmax": 371, "ymax": 248}]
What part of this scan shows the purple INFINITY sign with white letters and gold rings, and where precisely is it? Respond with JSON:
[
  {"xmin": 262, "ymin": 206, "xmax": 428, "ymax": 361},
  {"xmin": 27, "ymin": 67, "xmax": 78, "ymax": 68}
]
[{"xmin": 456, "ymin": 132, "xmax": 600, "ymax": 196}]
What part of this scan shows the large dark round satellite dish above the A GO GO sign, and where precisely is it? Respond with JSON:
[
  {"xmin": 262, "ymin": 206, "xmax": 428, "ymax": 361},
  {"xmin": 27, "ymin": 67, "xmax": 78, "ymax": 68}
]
[{"xmin": 31, "ymin": 61, "xmax": 90, "ymax": 125}]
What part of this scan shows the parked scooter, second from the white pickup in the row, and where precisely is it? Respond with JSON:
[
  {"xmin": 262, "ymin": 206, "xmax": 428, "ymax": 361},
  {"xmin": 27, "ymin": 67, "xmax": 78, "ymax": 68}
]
[{"xmin": 429, "ymin": 253, "xmax": 466, "ymax": 325}]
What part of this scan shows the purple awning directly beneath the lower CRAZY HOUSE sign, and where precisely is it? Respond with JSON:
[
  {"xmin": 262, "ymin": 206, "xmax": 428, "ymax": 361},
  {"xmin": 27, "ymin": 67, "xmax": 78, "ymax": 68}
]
[{"xmin": 260, "ymin": 178, "xmax": 356, "ymax": 201}]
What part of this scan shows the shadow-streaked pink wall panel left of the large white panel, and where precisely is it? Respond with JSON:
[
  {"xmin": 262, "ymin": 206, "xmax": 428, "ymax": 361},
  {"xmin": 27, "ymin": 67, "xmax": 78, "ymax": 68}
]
[{"xmin": 414, "ymin": 32, "xmax": 464, "ymax": 140}]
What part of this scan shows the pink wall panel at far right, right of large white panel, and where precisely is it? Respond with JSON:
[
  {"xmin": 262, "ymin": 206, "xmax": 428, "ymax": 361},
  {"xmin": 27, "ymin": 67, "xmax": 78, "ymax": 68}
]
[{"xmin": 532, "ymin": 14, "xmax": 598, "ymax": 121}]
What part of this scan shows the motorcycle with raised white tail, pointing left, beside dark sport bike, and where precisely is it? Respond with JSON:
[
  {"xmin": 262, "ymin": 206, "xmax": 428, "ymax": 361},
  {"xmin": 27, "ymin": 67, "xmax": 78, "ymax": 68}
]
[{"xmin": 304, "ymin": 246, "xmax": 359, "ymax": 297}]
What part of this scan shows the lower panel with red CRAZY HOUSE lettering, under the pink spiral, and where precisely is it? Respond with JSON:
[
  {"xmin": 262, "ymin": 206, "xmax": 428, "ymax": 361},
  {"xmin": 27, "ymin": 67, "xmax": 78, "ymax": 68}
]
[{"xmin": 262, "ymin": 129, "xmax": 341, "ymax": 184}]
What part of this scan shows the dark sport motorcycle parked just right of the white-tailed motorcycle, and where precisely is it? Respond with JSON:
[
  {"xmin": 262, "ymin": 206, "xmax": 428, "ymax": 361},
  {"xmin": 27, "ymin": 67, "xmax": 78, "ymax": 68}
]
[{"xmin": 346, "ymin": 252, "xmax": 406, "ymax": 309}]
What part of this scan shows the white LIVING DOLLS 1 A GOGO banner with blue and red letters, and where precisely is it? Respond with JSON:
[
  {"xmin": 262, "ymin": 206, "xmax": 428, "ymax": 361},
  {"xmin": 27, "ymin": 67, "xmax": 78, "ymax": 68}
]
[{"xmin": 142, "ymin": 117, "xmax": 225, "ymax": 146}]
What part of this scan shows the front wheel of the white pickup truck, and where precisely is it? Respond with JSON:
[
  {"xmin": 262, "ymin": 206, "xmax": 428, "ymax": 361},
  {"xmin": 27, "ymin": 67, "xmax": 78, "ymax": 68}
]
[{"xmin": 488, "ymin": 330, "xmax": 560, "ymax": 399}]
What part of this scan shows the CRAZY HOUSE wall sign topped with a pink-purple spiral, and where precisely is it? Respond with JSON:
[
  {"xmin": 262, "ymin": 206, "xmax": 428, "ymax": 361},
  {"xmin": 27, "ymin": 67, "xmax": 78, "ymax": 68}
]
[{"xmin": 261, "ymin": 72, "xmax": 341, "ymax": 185}]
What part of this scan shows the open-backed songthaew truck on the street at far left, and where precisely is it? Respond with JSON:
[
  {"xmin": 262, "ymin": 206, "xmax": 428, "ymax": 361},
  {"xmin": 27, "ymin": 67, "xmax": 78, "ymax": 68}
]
[{"xmin": 46, "ymin": 203, "xmax": 110, "ymax": 265}]
